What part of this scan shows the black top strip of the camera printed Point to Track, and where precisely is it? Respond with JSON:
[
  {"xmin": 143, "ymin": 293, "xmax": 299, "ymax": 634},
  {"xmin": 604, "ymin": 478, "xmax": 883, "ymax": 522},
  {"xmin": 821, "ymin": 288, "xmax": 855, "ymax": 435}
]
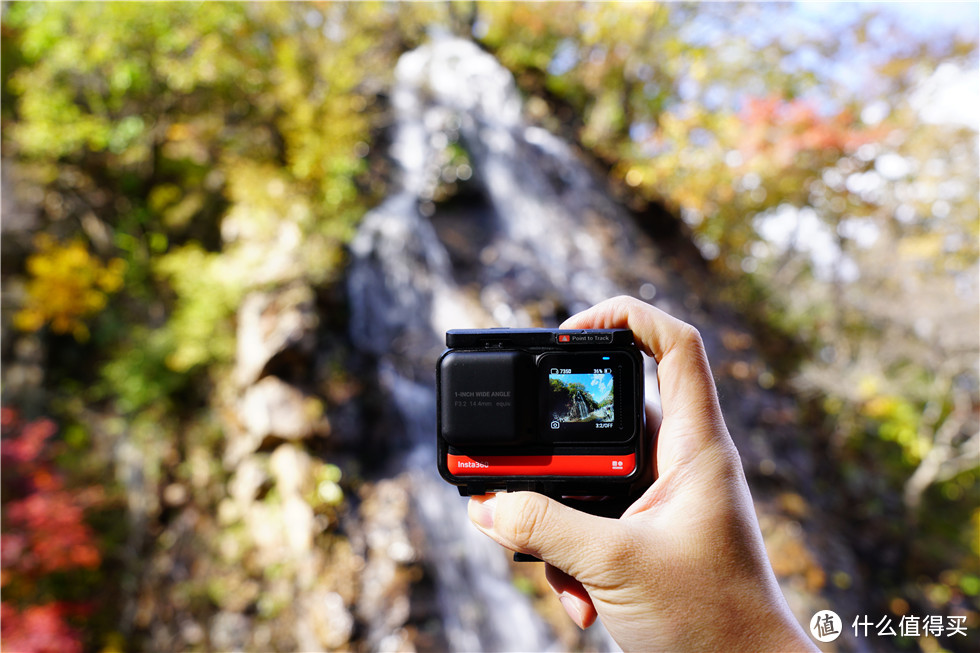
[{"xmin": 446, "ymin": 328, "xmax": 635, "ymax": 349}]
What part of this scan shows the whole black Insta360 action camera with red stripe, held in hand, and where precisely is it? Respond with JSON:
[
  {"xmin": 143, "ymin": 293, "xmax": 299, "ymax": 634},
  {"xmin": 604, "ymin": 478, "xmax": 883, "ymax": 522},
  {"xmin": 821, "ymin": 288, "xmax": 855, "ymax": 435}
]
[{"xmin": 436, "ymin": 329, "xmax": 650, "ymax": 498}]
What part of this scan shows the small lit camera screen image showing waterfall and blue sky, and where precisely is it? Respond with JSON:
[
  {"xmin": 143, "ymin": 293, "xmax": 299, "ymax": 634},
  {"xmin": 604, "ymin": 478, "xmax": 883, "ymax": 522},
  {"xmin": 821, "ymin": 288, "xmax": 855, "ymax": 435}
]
[{"xmin": 547, "ymin": 368, "xmax": 616, "ymax": 429}]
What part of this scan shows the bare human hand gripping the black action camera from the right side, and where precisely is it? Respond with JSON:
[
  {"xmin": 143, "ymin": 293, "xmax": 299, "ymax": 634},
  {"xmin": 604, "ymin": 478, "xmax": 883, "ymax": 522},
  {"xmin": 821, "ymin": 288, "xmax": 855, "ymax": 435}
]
[{"xmin": 469, "ymin": 297, "xmax": 816, "ymax": 651}]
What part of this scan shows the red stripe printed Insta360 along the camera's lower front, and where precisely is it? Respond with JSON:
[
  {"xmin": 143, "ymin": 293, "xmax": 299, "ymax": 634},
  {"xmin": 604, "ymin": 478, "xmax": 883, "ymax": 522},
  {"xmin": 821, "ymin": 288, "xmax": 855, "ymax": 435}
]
[{"xmin": 446, "ymin": 453, "xmax": 636, "ymax": 476}]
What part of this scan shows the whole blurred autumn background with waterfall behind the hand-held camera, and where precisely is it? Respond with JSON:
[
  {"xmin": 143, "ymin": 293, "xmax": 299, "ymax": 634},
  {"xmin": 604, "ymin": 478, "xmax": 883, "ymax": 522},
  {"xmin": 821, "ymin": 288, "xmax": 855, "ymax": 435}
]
[{"xmin": 0, "ymin": 2, "xmax": 980, "ymax": 651}]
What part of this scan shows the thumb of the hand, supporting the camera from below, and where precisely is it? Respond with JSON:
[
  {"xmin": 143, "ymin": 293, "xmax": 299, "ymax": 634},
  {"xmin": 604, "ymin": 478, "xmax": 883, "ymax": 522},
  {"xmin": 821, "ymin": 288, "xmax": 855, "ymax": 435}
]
[{"xmin": 468, "ymin": 492, "xmax": 622, "ymax": 580}]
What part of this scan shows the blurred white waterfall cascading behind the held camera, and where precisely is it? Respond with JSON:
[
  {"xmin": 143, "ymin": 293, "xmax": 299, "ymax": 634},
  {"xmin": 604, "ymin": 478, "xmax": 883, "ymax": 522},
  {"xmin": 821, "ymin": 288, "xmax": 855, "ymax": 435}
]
[{"xmin": 348, "ymin": 38, "xmax": 672, "ymax": 651}]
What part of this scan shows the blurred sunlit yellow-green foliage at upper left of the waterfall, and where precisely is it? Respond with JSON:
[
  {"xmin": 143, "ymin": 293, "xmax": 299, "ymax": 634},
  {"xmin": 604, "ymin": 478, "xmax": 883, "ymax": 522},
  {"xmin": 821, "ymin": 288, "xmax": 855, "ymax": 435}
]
[{"xmin": 5, "ymin": 2, "xmax": 392, "ymax": 398}]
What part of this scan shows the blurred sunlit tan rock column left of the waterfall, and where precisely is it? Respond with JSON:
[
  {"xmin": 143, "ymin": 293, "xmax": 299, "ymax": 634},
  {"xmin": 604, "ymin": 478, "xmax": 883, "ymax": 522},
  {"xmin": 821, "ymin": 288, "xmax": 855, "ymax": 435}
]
[{"xmin": 156, "ymin": 143, "xmax": 432, "ymax": 651}]
